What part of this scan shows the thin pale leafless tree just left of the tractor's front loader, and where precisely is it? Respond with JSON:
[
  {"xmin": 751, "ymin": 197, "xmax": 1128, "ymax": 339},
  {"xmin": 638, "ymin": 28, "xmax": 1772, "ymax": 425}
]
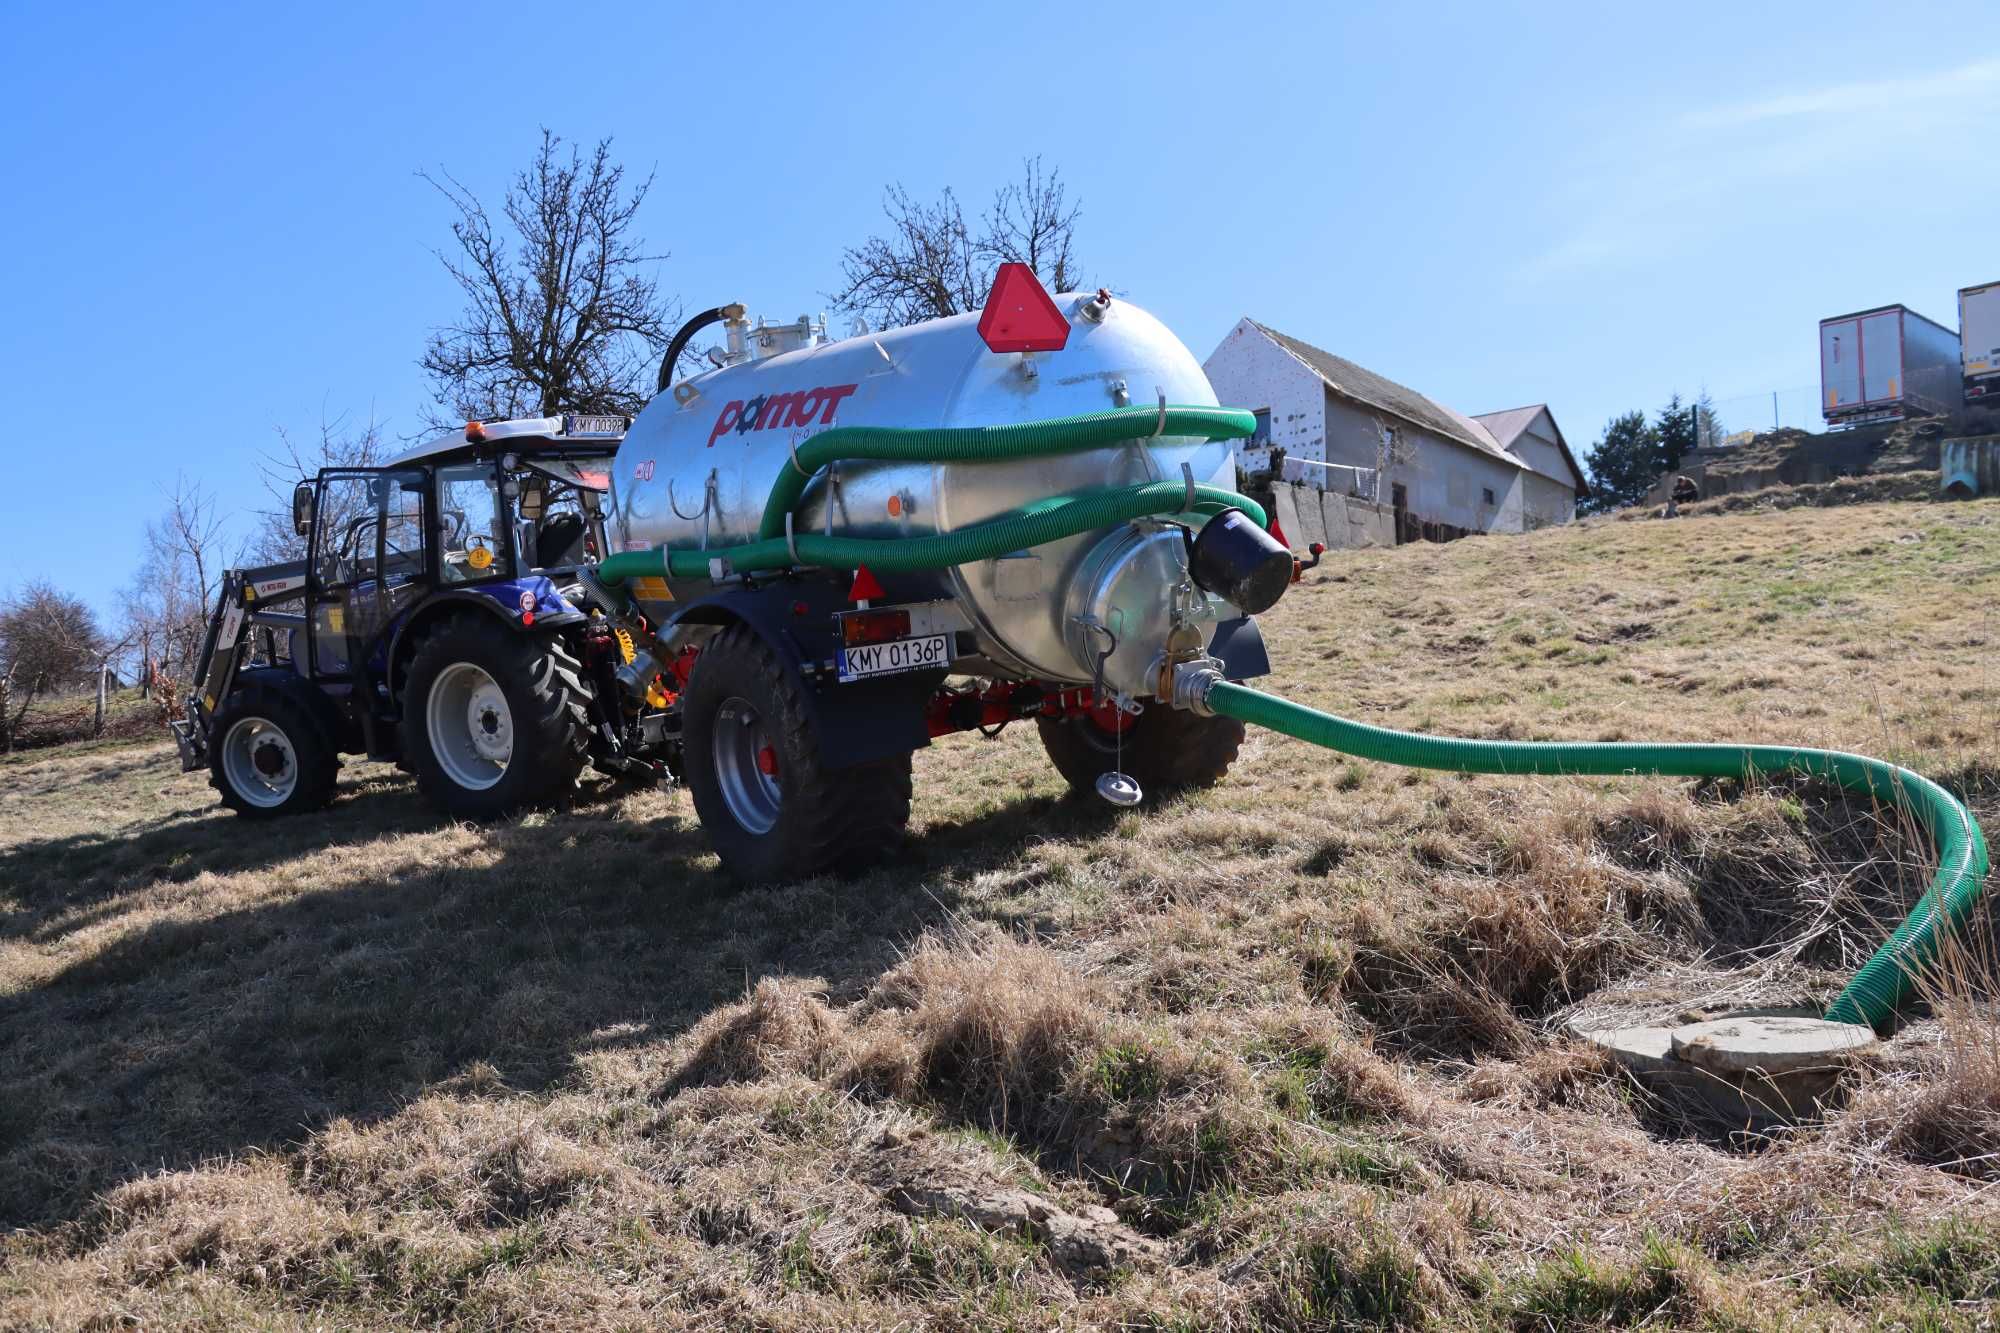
[{"xmin": 124, "ymin": 476, "xmax": 224, "ymax": 689}]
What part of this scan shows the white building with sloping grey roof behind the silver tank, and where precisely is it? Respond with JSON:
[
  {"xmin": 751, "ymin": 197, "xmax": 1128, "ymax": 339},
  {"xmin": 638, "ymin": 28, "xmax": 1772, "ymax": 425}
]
[{"xmin": 1202, "ymin": 318, "xmax": 1590, "ymax": 534}]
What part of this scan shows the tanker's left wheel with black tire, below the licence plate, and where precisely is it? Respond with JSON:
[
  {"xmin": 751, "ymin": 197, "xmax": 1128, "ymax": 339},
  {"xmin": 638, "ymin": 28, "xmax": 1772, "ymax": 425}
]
[{"xmin": 682, "ymin": 624, "xmax": 910, "ymax": 885}]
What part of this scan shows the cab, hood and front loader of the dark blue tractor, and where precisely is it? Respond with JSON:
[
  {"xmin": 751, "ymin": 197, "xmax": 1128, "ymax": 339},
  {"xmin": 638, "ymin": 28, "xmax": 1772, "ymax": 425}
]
[{"xmin": 174, "ymin": 414, "xmax": 626, "ymax": 792}]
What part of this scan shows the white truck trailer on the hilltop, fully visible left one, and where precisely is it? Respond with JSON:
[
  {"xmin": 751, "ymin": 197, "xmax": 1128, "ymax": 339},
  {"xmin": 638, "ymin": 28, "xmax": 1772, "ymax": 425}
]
[{"xmin": 1820, "ymin": 306, "xmax": 1960, "ymax": 426}]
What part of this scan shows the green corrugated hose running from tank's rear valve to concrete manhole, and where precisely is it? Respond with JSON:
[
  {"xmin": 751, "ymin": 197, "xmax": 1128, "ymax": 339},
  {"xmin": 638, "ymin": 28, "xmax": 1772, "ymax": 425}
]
[{"xmin": 1208, "ymin": 681, "xmax": 1986, "ymax": 1033}]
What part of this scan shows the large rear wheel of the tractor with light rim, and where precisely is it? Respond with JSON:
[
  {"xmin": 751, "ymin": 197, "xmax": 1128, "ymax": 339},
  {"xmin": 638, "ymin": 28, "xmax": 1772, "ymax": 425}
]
[{"xmin": 402, "ymin": 614, "xmax": 590, "ymax": 819}]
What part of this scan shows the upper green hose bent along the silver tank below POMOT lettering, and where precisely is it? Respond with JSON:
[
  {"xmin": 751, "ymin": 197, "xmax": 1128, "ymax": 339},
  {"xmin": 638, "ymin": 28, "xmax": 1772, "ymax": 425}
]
[{"xmin": 758, "ymin": 406, "xmax": 1256, "ymax": 540}]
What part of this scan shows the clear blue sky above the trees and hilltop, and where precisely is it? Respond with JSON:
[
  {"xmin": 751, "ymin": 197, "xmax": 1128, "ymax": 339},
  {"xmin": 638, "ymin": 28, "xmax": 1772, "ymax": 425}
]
[{"xmin": 0, "ymin": 0, "xmax": 2000, "ymax": 610}]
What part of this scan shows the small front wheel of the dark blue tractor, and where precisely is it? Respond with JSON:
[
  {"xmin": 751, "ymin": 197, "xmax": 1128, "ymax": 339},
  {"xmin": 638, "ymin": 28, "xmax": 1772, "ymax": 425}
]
[{"xmin": 208, "ymin": 681, "xmax": 340, "ymax": 819}]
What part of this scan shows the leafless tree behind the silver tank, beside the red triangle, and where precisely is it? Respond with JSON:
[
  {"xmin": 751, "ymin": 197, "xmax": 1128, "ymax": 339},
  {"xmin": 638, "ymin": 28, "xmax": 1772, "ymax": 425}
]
[{"xmin": 834, "ymin": 158, "xmax": 1082, "ymax": 328}]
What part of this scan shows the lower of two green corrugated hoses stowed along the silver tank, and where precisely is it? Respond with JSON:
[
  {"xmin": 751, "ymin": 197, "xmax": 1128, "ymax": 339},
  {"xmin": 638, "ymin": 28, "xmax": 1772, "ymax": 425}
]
[{"xmin": 598, "ymin": 482, "xmax": 1266, "ymax": 584}]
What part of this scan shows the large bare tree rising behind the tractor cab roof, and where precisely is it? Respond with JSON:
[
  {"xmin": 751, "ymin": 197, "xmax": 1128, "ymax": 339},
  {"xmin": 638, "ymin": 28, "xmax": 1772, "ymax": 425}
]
[{"xmin": 418, "ymin": 130, "xmax": 674, "ymax": 420}]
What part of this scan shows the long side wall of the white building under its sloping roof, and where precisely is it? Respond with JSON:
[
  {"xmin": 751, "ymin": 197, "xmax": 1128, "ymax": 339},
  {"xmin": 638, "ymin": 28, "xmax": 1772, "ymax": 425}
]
[{"xmin": 1322, "ymin": 382, "xmax": 1528, "ymax": 532}]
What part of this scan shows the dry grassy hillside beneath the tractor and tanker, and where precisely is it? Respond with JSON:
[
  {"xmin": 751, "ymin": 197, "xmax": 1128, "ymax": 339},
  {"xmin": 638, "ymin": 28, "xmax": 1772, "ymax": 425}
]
[{"xmin": 0, "ymin": 492, "xmax": 2000, "ymax": 1329}]
